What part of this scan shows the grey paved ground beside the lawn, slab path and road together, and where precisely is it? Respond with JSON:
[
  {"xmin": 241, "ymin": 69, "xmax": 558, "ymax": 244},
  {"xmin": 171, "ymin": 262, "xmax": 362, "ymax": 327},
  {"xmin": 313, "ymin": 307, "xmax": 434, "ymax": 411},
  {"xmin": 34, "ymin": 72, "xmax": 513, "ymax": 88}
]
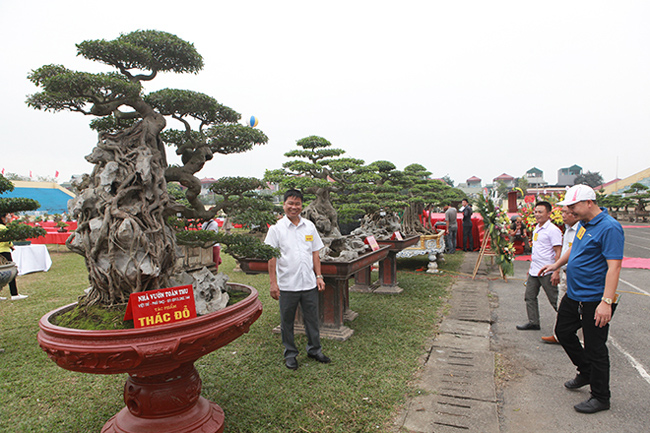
[{"xmin": 396, "ymin": 253, "xmax": 650, "ymax": 433}]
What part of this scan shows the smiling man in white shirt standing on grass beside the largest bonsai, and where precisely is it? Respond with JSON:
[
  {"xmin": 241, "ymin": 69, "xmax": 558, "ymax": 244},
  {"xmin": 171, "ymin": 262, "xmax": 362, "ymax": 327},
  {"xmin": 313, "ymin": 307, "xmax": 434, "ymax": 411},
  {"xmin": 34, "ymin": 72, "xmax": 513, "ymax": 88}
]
[{"xmin": 264, "ymin": 189, "xmax": 330, "ymax": 370}]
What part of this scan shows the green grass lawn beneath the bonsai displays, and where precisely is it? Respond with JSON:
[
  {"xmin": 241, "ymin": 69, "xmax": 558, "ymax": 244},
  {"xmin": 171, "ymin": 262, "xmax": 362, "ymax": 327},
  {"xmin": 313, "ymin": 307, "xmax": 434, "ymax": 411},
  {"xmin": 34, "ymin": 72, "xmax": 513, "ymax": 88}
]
[{"xmin": 0, "ymin": 247, "xmax": 463, "ymax": 433}]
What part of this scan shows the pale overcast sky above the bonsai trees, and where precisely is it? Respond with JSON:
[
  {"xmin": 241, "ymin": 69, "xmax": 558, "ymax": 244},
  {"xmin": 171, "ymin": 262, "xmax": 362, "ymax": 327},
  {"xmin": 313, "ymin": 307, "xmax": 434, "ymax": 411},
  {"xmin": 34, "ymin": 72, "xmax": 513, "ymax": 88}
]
[{"xmin": 0, "ymin": 0, "xmax": 650, "ymax": 185}]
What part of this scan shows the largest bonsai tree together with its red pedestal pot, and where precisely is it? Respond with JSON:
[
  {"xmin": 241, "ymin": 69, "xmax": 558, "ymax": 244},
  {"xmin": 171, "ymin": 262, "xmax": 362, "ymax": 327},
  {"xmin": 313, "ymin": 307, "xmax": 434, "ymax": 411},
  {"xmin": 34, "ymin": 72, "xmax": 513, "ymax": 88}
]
[{"xmin": 27, "ymin": 30, "xmax": 268, "ymax": 432}]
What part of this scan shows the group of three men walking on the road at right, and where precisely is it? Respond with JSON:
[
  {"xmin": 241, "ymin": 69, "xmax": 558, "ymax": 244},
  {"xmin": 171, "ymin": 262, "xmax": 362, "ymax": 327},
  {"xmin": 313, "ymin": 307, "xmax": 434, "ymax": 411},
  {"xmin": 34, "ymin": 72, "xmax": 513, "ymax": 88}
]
[{"xmin": 517, "ymin": 185, "xmax": 625, "ymax": 413}]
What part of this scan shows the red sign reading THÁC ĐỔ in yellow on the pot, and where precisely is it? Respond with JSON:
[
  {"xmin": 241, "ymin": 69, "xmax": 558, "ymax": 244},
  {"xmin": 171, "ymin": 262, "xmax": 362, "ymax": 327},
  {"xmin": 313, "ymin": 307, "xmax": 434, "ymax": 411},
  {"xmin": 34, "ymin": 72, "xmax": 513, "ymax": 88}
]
[{"xmin": 124, "ymin": 284, "xmax": 196, "ymax": 328}]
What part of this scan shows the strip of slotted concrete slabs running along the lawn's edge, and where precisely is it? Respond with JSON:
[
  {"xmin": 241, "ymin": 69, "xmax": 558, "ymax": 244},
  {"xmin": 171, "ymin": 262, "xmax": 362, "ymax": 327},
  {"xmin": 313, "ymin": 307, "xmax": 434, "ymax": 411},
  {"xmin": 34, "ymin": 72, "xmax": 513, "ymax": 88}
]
[{"xmin": 397, "ymin": 253, "xmax": 499, "ymax": 433}]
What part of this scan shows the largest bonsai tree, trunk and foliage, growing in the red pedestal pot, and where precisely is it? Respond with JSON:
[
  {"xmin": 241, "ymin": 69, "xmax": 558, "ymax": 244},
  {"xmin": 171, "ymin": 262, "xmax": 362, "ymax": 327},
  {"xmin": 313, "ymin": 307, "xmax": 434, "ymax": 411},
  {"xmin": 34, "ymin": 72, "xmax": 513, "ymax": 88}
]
[{"xmin": 27, "ymin": 30, "xmax": 267, "ymax": 304}]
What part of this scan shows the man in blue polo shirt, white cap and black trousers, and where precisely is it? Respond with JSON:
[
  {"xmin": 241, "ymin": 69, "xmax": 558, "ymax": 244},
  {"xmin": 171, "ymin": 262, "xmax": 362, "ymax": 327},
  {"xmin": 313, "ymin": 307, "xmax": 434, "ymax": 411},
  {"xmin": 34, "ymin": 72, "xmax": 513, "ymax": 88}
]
[{"xmin": 540, "ymin": 185, "xmax": 625, "ymax": 413}]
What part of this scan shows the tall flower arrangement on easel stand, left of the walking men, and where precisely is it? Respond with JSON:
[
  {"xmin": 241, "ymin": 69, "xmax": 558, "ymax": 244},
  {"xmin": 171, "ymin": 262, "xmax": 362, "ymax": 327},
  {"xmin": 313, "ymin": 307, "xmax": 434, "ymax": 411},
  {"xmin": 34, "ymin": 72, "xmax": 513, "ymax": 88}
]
[{"xmin": 478, "ymin": 198, "xmax": 515, "ymax": 275}]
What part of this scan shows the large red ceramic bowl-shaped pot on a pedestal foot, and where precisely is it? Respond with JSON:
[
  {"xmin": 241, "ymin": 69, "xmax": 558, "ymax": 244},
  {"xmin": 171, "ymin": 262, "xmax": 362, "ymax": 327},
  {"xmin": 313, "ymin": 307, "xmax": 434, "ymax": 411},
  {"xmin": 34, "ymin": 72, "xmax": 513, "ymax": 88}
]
[{"xmin": 38, "ymin": 283, "xmax": 262, "ymax": 433}]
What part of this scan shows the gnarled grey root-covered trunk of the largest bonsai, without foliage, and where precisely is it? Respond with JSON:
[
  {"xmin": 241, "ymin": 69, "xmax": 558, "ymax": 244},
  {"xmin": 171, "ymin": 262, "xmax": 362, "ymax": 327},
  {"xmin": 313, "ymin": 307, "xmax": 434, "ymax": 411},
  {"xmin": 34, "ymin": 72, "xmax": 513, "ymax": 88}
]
[{"xmin": 67, "ymin": 113, "xmax": 176, "ymax": 304}]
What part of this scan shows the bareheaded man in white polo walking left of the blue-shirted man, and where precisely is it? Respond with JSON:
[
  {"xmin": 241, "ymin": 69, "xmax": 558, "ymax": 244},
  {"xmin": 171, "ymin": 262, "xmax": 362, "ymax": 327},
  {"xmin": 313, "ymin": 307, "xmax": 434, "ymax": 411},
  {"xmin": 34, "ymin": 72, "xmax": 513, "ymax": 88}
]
[{"xmin": 517, "ymin": 201, "xmax": 562, "ymax": 331}]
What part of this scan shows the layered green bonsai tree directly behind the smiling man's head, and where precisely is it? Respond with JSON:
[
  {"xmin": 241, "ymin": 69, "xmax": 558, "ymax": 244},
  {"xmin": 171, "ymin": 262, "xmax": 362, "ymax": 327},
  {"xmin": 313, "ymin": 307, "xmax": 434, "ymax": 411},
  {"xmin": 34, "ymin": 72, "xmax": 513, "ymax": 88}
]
[{"xmin": 264, "ymin": 135, "xmax": 363, "ymax": 238}]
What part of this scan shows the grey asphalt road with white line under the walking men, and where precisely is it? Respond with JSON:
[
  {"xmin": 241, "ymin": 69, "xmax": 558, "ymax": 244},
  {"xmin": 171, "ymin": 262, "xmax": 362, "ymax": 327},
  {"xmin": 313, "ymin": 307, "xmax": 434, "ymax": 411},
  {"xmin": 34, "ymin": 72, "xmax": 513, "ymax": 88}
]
[{"xmin": 490, "ymin": 224, "xmax": 650, "ymax": 433}]
